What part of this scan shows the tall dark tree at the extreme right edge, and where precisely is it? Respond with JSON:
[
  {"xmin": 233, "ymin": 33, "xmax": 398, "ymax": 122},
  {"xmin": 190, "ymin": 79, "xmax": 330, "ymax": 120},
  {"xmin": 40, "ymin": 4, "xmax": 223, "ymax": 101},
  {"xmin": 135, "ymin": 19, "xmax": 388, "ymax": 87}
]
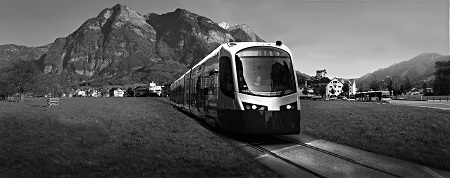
[{"xmin": 433, "ymin": 60, "xmax": 450, "ymax": 95}]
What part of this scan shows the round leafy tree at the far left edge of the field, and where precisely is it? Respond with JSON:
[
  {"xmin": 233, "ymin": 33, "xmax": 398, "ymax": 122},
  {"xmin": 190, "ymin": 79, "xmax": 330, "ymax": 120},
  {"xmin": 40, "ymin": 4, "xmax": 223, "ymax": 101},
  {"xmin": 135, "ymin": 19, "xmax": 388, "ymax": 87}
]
[{"xmin": 2, "ymin": 60, "xmax": 41, "ymax": 101}]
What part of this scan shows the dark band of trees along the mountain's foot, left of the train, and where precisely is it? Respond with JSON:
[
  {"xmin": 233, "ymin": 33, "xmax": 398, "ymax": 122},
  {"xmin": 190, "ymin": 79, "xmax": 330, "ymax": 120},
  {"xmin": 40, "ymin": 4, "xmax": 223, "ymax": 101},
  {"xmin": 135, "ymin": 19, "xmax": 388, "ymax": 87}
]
[{"xmin": 0, "ymin": 60, "xmax": 170, "ymax": 101}]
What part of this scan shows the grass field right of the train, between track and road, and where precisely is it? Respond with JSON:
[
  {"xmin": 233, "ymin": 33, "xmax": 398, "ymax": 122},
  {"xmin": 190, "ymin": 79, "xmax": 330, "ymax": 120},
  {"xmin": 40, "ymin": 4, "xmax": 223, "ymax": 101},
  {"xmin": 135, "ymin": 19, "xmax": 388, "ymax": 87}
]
[{"xmin": 301, "ymin": 100, "xmax": 450, "ymax": 171}]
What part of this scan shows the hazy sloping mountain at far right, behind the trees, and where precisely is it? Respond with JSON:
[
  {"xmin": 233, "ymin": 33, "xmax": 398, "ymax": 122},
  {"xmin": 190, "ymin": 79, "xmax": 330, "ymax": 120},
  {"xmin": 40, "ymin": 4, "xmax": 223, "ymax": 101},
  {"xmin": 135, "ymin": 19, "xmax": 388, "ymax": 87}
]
[{"xmin": 356, "ymin": 53, "xmax": 450, "ymax": 86}]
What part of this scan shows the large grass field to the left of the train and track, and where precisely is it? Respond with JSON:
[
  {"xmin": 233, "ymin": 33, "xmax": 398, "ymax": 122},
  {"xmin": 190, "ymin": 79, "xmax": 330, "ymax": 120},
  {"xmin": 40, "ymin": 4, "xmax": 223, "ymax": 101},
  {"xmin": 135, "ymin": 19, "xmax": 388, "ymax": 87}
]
[{"xmin": 0, "ymin": 98, "xmax": 278, "ymax": 177}]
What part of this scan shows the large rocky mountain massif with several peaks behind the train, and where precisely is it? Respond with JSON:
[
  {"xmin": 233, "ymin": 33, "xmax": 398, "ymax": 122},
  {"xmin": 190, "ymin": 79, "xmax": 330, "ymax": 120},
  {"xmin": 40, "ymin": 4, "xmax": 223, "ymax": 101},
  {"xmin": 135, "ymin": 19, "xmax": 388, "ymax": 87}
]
[{"xmin": 0, "ymin": 4, "xmax": 263, "ymax": 83}]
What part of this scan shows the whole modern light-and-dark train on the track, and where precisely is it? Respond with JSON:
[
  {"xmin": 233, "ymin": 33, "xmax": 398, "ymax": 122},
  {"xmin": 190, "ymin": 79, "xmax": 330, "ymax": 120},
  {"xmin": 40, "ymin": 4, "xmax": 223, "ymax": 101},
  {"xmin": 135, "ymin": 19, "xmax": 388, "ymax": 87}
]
[{"xmin": 169, "ymin": 41, "xmax": 301, "ymax": 135}]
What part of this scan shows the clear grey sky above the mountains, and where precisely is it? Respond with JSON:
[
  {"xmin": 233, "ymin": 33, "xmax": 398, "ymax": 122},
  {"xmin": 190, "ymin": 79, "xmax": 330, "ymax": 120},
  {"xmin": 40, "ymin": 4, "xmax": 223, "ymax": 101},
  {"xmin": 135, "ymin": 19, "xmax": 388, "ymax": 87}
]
[{"xmin": 0, "ymin": 0, "xmax": 450, "ymax": 78}]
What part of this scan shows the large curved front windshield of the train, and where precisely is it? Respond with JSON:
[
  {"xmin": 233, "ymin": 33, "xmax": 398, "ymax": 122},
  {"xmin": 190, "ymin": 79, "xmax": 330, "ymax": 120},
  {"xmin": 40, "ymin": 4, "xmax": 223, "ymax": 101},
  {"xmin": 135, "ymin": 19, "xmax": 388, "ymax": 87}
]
[{"xmin": 235, "ymin": 47, "xmax": 297, "ymax": 96}]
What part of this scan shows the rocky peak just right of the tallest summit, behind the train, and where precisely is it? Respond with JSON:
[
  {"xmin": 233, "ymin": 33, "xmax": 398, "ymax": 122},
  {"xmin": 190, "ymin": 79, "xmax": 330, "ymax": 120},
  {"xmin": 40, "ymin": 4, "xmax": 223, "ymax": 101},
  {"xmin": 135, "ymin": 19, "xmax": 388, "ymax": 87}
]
[{"xmin": 146, "ymin": 9, "xmax": 233, "ymax": 66}]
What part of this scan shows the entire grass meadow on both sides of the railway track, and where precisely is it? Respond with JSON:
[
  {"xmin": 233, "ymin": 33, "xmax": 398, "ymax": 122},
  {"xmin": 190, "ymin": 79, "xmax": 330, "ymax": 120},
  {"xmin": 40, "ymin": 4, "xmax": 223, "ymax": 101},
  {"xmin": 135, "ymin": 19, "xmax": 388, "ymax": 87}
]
[{"xmin": 0, "ymin": 97, "xmax": 450, "ymax": 177}]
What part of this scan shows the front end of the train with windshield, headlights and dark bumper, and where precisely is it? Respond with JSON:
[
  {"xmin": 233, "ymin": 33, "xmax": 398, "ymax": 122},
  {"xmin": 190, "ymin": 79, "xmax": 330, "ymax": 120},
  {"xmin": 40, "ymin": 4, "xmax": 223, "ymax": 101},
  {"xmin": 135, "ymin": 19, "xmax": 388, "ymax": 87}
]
[{"xmin": 218, "ymin": 44, "xmax": 300, "ymax": 135}]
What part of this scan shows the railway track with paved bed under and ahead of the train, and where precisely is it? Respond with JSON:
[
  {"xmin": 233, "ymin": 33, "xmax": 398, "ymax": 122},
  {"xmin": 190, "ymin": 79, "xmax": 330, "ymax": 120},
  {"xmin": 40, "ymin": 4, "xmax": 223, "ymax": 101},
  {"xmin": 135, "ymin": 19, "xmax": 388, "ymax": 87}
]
[{"xmin": 162, "ymin": 97, "xmax": 448, "ymax": 178}]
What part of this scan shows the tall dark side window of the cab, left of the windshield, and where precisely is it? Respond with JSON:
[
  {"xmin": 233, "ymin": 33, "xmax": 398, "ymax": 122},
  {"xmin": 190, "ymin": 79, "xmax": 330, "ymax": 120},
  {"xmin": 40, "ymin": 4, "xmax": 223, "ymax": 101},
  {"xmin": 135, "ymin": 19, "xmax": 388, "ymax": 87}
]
[{"xmin": 219, "ymin": 56, "xmax": 234, "ymax": 99}]
